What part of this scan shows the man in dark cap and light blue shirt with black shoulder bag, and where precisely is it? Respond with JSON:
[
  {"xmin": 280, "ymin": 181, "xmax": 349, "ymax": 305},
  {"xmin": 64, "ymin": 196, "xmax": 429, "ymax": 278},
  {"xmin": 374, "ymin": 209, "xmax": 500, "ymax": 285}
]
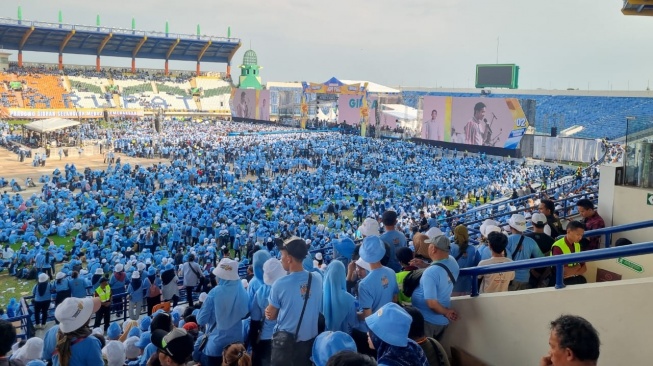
[{"xmin": 265, "ymin": 237, "xmax": 322, "ymax": 366}]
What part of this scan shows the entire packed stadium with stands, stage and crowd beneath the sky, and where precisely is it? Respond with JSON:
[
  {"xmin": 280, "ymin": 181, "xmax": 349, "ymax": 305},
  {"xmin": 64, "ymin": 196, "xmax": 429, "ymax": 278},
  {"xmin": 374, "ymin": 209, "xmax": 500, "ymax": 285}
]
[{"xmin": 0, "ymin": 4, "xmax": 653, "ymax": 365}]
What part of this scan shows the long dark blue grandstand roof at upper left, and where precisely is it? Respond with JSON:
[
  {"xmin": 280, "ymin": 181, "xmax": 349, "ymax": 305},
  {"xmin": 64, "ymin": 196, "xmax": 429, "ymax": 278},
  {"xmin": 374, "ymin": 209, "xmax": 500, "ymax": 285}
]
[{"xmin": 0, "ymin": 18, "xmax": 241, "ymax": 63}]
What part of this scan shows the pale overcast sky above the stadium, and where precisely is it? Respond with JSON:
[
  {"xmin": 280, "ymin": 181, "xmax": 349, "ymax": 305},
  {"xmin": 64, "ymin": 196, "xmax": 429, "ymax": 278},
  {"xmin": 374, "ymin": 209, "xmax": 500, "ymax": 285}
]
[{"xmin": 0, "ymin": 0, "xmax": 653, "ymax": 90}]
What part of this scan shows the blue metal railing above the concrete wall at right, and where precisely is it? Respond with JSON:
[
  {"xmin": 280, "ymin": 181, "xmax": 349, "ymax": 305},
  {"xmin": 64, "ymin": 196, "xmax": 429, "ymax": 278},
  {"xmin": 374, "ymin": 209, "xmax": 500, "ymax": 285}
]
[{"xmin": 459, "ymin": 220, "xmax": 653, "ymax": 297}]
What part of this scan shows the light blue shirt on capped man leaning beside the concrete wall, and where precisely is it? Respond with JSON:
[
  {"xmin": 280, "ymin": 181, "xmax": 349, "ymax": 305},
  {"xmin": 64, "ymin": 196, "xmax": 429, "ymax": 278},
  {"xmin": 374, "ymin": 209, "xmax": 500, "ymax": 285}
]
[{"xmin": 411, "ymin": 256, "xmax": 460, "ymax": 325}]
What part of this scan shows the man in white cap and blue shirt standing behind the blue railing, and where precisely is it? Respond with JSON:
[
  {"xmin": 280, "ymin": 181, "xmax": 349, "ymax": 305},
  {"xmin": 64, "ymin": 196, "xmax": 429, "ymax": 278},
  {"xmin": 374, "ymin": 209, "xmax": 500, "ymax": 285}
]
[{"xmin": 506, "ymin": 214, "xmax": 544, "ymax": 291}]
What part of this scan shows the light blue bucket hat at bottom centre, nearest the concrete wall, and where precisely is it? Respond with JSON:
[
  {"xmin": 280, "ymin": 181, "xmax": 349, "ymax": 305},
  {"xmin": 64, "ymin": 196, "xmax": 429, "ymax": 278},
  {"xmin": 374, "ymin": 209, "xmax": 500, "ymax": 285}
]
[{"xmin": 365, "ymin": 302, "xmax": 413, "ymax": 347}]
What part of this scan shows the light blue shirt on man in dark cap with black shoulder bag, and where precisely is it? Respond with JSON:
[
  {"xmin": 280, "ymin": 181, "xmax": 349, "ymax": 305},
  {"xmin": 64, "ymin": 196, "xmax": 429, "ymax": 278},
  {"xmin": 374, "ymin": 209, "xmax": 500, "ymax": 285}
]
[{"xmin": 268, "ymin": 271, "xmax": 322, "ymax": 341}]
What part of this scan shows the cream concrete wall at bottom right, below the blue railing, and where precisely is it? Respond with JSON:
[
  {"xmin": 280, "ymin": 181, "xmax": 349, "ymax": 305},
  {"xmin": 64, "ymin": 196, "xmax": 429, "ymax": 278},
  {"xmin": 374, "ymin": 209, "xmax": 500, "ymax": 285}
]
[{"xmin": 443, "ymin": 278, "xmax": 653, "ymax": 366}]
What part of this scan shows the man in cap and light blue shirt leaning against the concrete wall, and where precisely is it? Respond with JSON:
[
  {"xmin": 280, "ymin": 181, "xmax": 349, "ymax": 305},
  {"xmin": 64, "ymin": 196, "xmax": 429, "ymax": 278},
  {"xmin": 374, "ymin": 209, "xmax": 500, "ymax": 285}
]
[{"xmin": 411, "ymin": 235, "xmax": 460, "ymax": 340}]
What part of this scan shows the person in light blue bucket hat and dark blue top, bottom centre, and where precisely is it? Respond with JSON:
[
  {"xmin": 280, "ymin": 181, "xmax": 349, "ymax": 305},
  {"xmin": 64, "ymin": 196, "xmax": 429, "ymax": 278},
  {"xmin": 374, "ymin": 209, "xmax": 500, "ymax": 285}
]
[{"xmin": 365, "ymin": 303, "xmax": 429, "ymax": 366}]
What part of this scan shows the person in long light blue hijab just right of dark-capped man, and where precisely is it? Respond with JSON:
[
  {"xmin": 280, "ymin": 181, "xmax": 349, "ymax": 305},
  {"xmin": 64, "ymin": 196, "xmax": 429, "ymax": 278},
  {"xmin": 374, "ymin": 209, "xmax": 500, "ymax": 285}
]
[{"xmin": 322, "ymin": 261, "xmax": 358, "ymax": 334}]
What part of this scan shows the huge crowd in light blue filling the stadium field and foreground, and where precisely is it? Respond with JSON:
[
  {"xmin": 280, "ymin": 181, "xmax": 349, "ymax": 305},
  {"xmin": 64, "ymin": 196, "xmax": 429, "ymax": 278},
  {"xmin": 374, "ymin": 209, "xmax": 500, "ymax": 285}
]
[{"xmin": 0, "ymin": 120, "xmax": 602, "ymax": 365}]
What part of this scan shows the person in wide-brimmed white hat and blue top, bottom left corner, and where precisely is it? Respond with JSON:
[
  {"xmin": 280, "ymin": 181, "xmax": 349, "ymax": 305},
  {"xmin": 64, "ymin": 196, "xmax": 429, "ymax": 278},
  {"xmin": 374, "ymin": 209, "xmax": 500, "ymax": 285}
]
[{"xmin": 52, "ymin": 297, "xmax": 104, "ymax": 366}]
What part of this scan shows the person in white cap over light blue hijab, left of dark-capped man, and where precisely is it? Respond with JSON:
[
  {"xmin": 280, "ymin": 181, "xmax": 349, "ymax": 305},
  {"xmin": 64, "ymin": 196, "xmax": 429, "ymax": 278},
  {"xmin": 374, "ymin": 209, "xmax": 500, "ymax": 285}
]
[{"xmin": 197, "ymin": 258, "xmax": 249, "ymax": 365}]
